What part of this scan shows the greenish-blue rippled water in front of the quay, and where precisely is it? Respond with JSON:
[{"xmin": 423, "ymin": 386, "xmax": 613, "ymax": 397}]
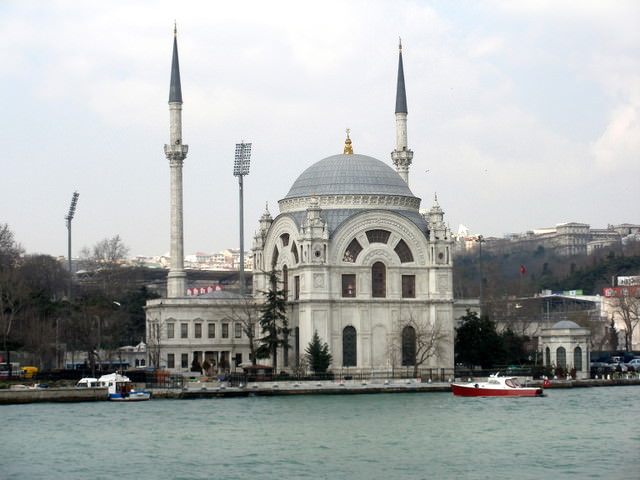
[{"xmin": 0, "ymin": 386, "xmax": 640, "ymax": 480}]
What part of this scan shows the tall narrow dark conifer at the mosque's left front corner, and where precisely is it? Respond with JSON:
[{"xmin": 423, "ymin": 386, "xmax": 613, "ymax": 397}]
[{"xmin": 256, "ymin": 270, "xmax": 289, "ymax": 372}]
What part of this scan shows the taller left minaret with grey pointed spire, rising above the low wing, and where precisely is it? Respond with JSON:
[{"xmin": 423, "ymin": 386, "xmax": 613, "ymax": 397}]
[{"xmin": 164, "ymin": 26, "xmax": 189, "ymax": 298}]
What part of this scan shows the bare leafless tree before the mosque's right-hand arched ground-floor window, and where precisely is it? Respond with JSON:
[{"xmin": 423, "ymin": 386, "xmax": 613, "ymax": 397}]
[{"xmin": 390, "ymin": 313, "xmax": 450, "ymax": 377}]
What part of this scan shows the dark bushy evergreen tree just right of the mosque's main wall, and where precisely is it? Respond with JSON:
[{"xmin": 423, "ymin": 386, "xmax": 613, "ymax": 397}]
[{"xmin": 455, "ymin": 309, "xmax": 505, "ymax": 368}]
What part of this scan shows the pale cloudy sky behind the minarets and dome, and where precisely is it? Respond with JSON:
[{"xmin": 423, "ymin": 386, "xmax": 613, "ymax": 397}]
[{"xmin": 0, "ymin": 0, "xmax": 640, "ymax": 256}]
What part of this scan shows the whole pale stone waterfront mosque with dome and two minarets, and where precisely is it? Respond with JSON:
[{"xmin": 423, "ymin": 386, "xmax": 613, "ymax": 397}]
[{"xmin": 146, "ymin": 30, "xmax": 454, "ymax": 373}]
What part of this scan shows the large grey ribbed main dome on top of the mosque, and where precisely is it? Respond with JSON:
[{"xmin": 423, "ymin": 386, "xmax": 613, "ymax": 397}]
[{"xmin": 284, "ymin": 154, "xmax": 415, "ymax": 199}]
